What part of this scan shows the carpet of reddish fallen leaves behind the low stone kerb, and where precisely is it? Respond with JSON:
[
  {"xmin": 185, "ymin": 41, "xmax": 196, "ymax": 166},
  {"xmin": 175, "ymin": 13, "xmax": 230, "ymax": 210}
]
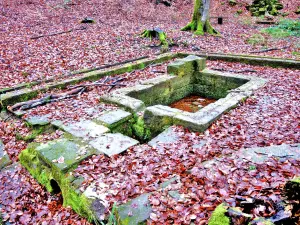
[{"xmin": 0, "ymin": 0, "xmax": 299, "ymax": 88}]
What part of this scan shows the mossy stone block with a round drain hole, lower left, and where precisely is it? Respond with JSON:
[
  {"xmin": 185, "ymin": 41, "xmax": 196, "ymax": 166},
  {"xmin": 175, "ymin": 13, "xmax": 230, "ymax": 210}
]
[{"xmin": 19, "ymin": 140, "xmax": 96, "ymax": 222}]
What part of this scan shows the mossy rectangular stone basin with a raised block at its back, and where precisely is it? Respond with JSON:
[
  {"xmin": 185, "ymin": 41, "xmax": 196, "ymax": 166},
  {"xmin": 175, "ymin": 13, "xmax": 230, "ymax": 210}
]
[{"xmin": 102, "ymin": 55, "xmax": 266, "ymax": 134}]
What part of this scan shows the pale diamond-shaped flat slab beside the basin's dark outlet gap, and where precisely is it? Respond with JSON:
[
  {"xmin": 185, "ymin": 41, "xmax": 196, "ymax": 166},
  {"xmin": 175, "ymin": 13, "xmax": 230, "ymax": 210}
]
[{"xmin": 89, "ymin": 133, "xmax": 139, "ymax": 156}]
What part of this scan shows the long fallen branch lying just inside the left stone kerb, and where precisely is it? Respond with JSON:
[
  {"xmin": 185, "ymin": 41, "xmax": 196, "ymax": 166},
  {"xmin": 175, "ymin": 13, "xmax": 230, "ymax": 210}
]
[{"xmin": 7, "ymin": 87, "xmax": 86, "ymax": 112}]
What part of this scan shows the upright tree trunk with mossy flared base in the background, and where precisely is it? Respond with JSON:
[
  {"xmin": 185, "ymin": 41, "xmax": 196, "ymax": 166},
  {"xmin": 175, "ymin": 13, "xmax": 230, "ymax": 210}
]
[{"xmin": 181, "ymin": 0, "xmax": 220, "ymax": 36}]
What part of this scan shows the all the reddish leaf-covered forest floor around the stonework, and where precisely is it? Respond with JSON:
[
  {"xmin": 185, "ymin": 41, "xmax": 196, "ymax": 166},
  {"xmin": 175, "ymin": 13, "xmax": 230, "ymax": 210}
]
[{"xmin": 0, "ymin": 0, "xmax": 300, "ymax": 224}]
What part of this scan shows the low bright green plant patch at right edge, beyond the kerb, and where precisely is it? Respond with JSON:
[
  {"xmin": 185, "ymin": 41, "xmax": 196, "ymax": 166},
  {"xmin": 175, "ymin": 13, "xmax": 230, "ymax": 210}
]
[{"xmin": 262, "ymin": 19, "xmax": 300, "ymax": 38}]
